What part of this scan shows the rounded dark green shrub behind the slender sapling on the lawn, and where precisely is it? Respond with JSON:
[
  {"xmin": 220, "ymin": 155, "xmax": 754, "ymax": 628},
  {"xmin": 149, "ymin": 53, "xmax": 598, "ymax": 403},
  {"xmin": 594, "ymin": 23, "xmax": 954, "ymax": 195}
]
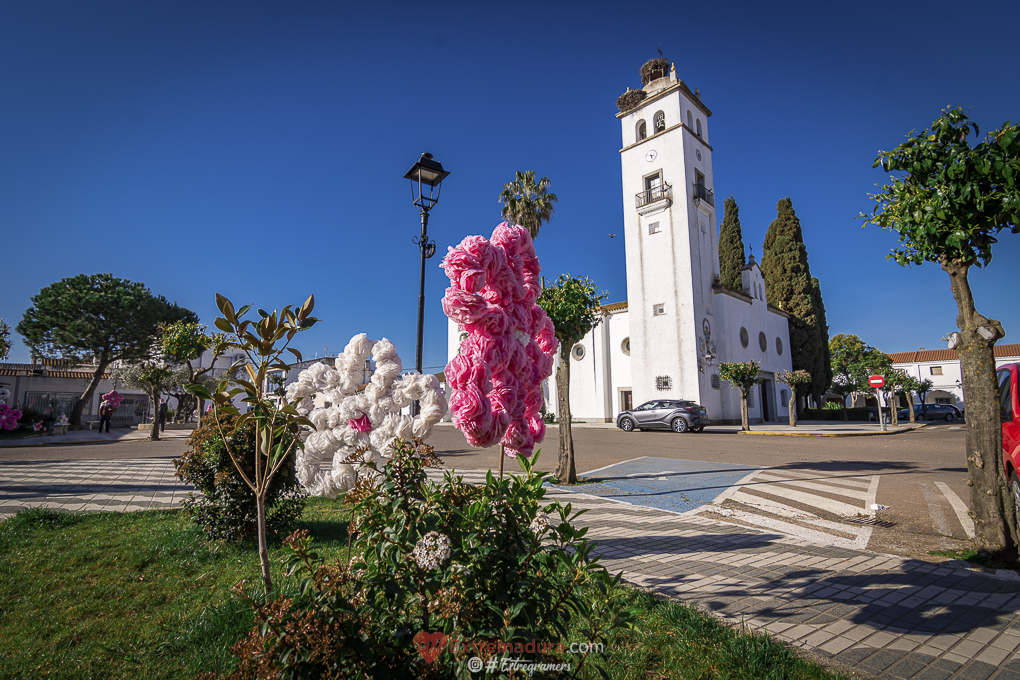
[{"xmin": 173, "ymin": 413, "xmax": 305, "ymax": 541}]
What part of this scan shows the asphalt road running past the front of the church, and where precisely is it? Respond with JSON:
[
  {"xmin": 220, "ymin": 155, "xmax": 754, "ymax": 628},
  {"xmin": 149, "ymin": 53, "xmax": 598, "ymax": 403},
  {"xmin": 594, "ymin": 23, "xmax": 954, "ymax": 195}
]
[{"xmin": 0, "ymin": 425, "xmax": 970, "ymax": 557}]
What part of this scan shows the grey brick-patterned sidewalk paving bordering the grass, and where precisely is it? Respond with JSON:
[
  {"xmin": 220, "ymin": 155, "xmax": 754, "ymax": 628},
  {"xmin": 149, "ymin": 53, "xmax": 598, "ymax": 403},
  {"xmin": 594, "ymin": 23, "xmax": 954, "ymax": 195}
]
[{"xmin": 0, "ymin": 459, "xmax": 1020, "ymax": 680}]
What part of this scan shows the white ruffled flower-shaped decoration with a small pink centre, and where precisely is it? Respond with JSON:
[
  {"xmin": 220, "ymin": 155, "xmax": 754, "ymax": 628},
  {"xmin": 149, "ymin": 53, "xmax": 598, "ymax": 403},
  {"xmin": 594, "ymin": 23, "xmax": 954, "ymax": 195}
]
[{"xmin": 287, "ymin": 333, "xmax": 447, "ymax": 499}]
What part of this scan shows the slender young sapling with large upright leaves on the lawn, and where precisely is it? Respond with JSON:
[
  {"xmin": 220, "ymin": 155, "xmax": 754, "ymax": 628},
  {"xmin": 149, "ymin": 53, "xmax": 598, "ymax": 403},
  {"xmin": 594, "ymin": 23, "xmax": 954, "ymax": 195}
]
[{"xmin": 187, "ymin": 293, "xmax": 318, "ymax": 592}]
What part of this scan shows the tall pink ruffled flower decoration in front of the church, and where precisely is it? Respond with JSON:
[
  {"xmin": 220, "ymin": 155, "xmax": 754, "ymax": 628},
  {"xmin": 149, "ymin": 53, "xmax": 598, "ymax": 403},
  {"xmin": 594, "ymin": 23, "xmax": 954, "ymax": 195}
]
[{"xmin": 443, "ymin": 222, "xmax": 558, "ymax": 456}]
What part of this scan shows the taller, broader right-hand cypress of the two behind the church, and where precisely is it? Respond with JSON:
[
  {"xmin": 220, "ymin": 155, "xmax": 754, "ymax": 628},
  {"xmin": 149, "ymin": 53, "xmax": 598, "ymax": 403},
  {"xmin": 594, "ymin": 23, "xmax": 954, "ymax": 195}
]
[{"xmin": 761, "ymin": 198, "xmax": 832, "ymax": 404}]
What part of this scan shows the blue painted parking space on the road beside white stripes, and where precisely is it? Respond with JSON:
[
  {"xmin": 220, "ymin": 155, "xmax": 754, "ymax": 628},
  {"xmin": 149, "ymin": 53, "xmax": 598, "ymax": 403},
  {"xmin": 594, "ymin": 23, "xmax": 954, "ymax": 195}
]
[{"xmin": 573, "ymin": 457, "xmax": 762, "ymax": 513}]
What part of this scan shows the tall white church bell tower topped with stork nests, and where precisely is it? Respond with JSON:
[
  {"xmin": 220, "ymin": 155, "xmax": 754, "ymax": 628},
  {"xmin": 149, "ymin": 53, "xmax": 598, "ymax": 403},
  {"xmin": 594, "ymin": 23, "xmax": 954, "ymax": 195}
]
[{"xmin": 616, "ymin": 56, "xmax": 722, "ymax": 417}]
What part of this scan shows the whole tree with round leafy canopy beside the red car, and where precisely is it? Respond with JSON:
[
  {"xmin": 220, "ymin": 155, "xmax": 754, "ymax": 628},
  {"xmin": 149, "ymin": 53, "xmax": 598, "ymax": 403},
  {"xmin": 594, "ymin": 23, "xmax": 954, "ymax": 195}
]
[{"xmin": 862, "ymin": 107, "xmax": 1020, "ymax": 559}]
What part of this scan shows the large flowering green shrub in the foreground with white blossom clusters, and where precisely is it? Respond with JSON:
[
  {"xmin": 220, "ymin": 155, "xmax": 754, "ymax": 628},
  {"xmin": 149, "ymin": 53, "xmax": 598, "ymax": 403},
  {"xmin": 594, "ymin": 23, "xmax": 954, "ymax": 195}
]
[{"xmin": 218, "ymin": 443, "xmax": 633, "ymax": 678}]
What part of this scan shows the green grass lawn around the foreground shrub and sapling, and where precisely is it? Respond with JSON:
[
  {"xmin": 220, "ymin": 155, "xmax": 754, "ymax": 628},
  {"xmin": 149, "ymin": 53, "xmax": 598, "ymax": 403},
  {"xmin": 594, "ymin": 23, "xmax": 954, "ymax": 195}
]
[{"xmin": 0, "ymin": 499, "xmax": 843, "ymax": 680}]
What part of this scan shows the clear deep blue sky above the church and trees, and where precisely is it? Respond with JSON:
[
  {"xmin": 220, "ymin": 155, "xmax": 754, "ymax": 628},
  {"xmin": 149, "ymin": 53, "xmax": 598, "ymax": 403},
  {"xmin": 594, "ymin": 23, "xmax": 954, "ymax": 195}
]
[{"xmin": 0, "ymin": 0, "xmax": 1020, "ymax": 368}]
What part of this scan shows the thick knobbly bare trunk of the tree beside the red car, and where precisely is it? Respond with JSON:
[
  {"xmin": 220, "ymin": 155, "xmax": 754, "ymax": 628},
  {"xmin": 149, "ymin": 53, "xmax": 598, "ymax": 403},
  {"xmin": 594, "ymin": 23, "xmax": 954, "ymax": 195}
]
[{"xmin": 939, "ymin": 254, "xmax": 1016, "ymax": 558}]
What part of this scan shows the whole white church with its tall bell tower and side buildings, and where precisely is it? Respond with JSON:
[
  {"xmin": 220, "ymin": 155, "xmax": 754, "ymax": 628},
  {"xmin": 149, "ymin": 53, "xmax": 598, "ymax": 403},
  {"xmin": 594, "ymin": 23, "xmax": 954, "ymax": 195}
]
[{"xmin": 448, "ymin": 61, "xmax": 792, "ymax": 423}]
